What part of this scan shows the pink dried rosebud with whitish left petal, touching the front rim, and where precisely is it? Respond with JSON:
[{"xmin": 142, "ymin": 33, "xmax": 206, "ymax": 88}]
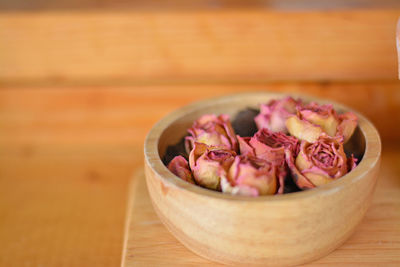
[{"xmin": 221, "ymin": 155, "xmax": 277, "ymax": 196}]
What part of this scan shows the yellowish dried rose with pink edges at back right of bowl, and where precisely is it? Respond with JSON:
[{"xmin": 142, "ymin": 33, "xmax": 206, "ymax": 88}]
[{"xmin": 286, "ymin": 102, "xmax": 357, "ymax": 143}]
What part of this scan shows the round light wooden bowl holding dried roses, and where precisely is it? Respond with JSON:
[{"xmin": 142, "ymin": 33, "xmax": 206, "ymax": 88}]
[{"xmin": 144, "ymin": 93, "xmax": 381, "ymax": 265}]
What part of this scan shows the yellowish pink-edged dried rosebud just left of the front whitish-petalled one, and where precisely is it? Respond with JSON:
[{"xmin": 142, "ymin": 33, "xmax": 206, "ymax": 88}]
[{"xmin": 189, "ymin": 142, "xmax": 236, "ymax": 190}]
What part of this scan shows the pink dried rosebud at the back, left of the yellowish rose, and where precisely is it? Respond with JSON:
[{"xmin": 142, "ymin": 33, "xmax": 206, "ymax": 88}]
[{"xmin": 254, "ymin": 97, "xmax": 300, "ymax": 133}]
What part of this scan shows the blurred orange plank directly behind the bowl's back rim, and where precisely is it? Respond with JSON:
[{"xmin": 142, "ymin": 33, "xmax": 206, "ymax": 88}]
[{"xmin": 0, "ymin": 82, "xmax": 400, "ymax": 145}]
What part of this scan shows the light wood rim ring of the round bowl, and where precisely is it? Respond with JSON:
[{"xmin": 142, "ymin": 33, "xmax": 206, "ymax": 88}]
[{"xmin": 144, "ymin": 91, "xmax": 382, "ymax": 201}]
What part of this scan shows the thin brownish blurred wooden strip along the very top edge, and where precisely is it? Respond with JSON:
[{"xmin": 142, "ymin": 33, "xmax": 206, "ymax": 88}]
[{"xmin": 0, "ymin": 0, "xmax": 400, "ymax": 11}]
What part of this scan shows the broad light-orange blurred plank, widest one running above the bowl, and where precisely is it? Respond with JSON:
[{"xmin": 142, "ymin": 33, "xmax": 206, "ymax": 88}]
[{"xmin": 0, "ymin": 8, "xmax": 400, "ymax": 84}]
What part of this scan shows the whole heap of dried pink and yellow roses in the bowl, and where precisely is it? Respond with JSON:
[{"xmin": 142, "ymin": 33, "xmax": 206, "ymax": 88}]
[{"xmin": 164, "ymin": 97, "xmax": 357, "ymax": 196}]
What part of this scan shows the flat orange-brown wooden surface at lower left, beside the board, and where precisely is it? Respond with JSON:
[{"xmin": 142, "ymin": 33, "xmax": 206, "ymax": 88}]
[{"xmin": 0, "ymin": 143, "xmax": 141, "ymax": 266}]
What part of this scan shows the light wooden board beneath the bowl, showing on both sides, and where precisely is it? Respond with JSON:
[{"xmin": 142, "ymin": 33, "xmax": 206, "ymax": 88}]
[{"xmin": 122, "ymin": 149, "xmax": 400, "ymax": 267}]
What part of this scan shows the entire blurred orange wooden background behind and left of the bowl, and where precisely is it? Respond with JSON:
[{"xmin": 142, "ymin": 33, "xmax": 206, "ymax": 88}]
[{"xmin": 0, "ymin": 0, "xmax": 400, "ymax": 266}]
